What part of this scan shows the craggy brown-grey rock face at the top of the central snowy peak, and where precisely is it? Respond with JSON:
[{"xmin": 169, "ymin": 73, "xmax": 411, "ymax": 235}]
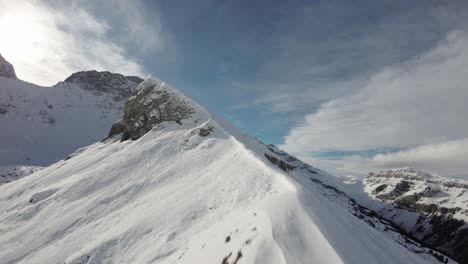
[{"xmin": 108, "ymin": 80, "xmax": 196, "ymax": 140}]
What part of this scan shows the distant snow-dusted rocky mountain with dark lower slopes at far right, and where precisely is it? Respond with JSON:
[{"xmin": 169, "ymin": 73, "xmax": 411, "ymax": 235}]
[{"xmin": 364, "ymin": 168, "xmax": 468, "ymax": 263}]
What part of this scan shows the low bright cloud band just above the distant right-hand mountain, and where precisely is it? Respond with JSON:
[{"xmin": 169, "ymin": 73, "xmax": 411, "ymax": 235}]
[{"xmin": 339, "ymin": 138, "xmax": 468, "ymax": 178}]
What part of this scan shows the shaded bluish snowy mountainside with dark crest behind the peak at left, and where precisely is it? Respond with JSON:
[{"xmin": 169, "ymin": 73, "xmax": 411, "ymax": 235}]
[{"xmin": 0, "ymin": 68, "xmax": 142, "ymax": 166}]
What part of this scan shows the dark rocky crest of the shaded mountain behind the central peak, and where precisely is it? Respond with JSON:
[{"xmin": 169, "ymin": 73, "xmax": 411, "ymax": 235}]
[{"xmin": 65, "ymin": 71, "xmax": 143, "ymax": 101}]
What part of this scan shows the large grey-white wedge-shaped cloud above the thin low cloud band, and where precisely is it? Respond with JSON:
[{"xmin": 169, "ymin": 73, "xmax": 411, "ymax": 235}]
[{"xmin": 282, "ymin": 31, "xmax": 468, "ymax": 155}]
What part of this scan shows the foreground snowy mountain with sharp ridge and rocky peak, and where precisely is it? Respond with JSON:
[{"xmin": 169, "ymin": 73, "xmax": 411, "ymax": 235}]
[{"xmin": 0, "ymin": 80, "xmax": 453, "ymax": 264}]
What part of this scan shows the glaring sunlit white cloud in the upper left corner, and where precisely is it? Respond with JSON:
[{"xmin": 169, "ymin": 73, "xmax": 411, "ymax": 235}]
[{"xmin": 0, "ymin": 0, "xmax": 160, "ymax": 85}]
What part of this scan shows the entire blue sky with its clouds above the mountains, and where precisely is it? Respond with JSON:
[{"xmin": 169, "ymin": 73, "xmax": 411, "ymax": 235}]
[{"xmin": 0, "ymin": 0, "xmax": 468, "ymax": 176}]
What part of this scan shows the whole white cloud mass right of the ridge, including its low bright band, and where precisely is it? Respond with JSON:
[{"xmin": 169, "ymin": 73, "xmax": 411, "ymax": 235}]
[{"xmin": 280, "ymin": 31, "xmax": 468, "ymax": 177}]
